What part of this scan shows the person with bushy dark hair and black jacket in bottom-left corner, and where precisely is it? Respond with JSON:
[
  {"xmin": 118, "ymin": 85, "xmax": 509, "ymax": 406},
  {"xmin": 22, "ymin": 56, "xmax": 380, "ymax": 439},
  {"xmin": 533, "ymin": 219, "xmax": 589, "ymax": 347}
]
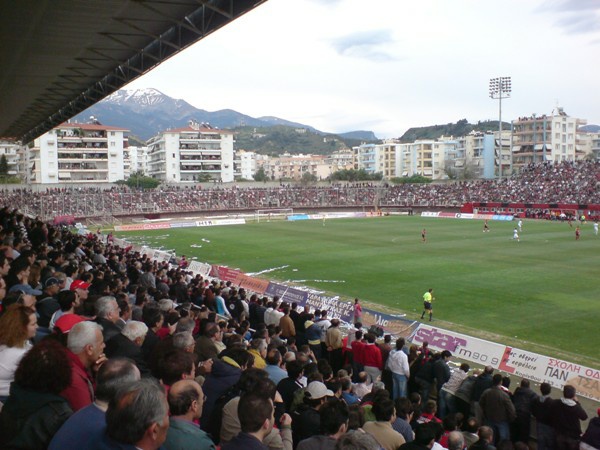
[{"xmin": 0, "ymin": 339, "xmax": 73, "ymax": 449}]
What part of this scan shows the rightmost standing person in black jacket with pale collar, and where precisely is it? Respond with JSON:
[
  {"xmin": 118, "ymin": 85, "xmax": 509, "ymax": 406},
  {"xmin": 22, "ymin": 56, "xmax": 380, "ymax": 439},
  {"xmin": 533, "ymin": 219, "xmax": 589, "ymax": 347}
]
[{"xmin": 550, "ymin": 384, "xmax": 587, "ymax": 450}]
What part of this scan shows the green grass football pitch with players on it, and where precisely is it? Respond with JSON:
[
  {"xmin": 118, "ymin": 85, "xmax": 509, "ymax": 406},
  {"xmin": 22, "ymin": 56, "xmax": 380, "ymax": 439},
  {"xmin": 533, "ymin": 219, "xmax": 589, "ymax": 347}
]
[{"xmin": 119, "ymin": 216, "xmax": 600, "ymax": 367}]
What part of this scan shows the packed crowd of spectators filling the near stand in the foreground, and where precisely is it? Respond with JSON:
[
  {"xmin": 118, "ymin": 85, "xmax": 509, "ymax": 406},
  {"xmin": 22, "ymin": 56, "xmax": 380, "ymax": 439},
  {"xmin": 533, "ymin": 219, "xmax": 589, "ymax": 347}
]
[{"xmin": 0, "ymin": 208, "xmax": 600, "ymax": 450}]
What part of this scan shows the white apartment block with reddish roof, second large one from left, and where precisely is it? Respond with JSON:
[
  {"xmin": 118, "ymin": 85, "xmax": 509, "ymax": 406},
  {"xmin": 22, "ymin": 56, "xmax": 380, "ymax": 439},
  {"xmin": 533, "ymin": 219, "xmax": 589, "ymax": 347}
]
[{"xmin": 147, "ymin": 121, "xmax": 234, "ymax": 183}]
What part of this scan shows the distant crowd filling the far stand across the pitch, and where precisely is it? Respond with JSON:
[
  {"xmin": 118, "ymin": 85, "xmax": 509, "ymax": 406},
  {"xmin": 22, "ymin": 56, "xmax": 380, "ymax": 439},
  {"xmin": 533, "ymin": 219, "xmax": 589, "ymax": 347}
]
[{"xmin": 0, "ymin": 161, "xmax": 600, "ymax": 217}]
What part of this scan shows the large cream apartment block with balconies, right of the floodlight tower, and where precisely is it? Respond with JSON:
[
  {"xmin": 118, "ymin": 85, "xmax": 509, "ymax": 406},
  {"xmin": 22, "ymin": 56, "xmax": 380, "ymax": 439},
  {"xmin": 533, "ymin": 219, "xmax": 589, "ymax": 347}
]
[{"xmin": 512, "ymin": 108, "xmax": 587, "ymax": 170}]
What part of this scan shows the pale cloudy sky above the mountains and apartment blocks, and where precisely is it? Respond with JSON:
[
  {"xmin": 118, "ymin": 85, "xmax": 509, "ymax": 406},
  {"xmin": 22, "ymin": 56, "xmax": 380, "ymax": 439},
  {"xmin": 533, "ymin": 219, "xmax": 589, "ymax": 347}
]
[{"xmin": 127, "ymin": 0, "xmax": 600, "ymax": 138}]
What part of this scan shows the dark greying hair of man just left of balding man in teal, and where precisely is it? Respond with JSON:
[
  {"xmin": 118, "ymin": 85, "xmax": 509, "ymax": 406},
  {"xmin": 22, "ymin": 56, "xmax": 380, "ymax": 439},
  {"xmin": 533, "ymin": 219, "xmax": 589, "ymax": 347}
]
[{"xmin": 106, "ymin": 378, "xmax": 169, "ymax": 445}]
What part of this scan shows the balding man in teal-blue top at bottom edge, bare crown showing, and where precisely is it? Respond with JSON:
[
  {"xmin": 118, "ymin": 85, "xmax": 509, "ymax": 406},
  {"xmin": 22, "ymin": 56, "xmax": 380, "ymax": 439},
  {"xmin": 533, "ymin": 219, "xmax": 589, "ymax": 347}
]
[{"xmin": 164, "ymin": 380, "xmax": 215, "ymax": 450}]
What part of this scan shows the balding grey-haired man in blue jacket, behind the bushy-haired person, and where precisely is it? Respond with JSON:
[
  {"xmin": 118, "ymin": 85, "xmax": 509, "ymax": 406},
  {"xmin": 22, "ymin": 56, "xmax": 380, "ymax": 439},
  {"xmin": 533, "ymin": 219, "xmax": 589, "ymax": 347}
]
[{"xmin": 48, "ymin": 358, "xmax": 140, "ymax": 450}]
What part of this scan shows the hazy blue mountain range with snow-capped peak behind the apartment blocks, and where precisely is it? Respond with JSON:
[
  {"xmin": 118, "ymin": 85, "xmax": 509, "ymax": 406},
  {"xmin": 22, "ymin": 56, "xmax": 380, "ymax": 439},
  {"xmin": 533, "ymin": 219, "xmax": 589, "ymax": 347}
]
[{"xmin": 73, "ymin": 88, "xmax": 377, "ymax": 141}]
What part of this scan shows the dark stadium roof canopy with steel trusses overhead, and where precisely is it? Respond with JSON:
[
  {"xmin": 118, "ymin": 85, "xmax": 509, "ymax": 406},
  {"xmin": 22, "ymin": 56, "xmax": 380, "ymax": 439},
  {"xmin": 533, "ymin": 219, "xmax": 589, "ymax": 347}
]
[{"xmin": 0, "ymin": 0, "xmax": 266, "ymax": 143}]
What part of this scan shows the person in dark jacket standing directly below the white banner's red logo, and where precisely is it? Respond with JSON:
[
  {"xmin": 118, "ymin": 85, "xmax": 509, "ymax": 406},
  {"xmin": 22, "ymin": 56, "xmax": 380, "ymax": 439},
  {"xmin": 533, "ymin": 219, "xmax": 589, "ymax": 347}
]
[{"xmin": 479, "ymin": 373, "xmax": 516, "ymax": 441}]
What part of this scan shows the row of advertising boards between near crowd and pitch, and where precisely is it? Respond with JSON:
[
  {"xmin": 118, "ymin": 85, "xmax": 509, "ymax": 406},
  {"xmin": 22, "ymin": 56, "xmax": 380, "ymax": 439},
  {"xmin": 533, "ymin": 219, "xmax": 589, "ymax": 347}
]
[{"xmin": 114, "ymin": 238, "xmax": 600, "ymax": 401}]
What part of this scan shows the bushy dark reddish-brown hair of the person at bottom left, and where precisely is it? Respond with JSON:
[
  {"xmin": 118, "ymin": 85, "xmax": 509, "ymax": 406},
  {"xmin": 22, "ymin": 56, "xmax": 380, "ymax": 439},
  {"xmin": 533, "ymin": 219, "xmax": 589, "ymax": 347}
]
[{"xmin": 15, "ymin": 339, "xmax": 71, "ymax": 394}]
